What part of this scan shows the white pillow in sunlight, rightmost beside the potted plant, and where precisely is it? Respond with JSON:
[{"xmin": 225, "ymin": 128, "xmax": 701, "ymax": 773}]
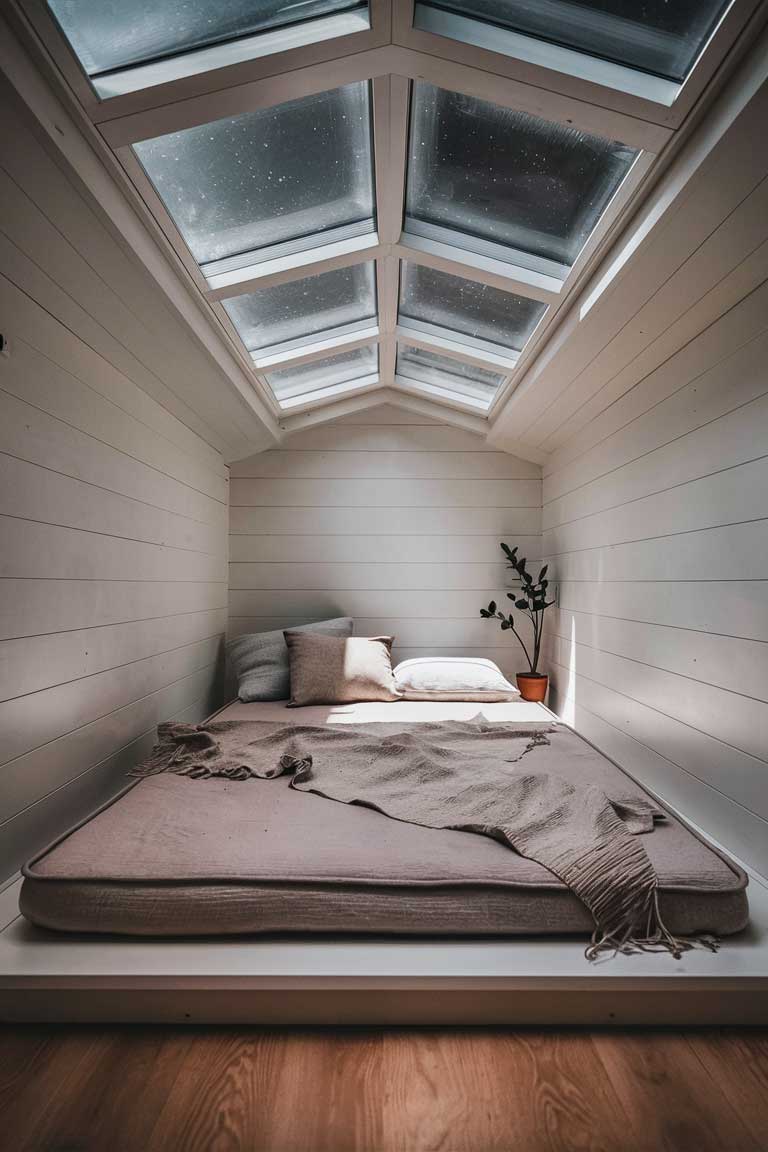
[{"xmin": 395, "ymin": 655, "xmax": 520, "ymax": 704}]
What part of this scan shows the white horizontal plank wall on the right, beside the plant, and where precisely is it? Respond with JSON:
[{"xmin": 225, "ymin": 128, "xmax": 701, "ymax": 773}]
[{"xmin": 542, "ymin": 274, "xmax": 768, "ymax": 874}]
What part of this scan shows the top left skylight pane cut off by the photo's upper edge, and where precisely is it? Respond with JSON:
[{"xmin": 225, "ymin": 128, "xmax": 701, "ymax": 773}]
[{"xmin": 48, "ymin": 0, "xmax": 364, "ymax": 86}]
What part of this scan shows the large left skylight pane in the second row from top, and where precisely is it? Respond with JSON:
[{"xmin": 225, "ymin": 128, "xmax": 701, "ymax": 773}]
[{"xmin": 134, "ymin": 83, "xmax": 373, "ymax": 264}]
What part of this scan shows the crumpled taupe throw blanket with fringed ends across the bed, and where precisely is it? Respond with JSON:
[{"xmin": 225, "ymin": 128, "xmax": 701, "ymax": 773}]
[{"xmin": 134, "ymin": 718, "xmax": 715, "ymax": 960}]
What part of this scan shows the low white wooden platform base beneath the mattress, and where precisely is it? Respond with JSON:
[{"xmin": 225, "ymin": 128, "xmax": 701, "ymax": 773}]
[{"xmin": 0, "ymin": 710, "xmax": 768, "ymax": 1028}]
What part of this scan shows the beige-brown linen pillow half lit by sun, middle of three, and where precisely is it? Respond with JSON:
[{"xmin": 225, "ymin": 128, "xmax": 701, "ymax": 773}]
[{"xmin": 283, "ymin": 630, "xmax": 401, "ymax": 707}]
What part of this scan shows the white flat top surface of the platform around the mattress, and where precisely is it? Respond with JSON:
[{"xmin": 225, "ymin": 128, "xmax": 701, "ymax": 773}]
[{"xmin": 0, "ymin": 866, "xmax": 768, "ymax": 990}]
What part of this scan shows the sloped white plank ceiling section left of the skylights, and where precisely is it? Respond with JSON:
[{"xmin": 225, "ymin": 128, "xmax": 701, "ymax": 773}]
[{"xmin": 0, "ymin": 76, "xmax": 273, "ymax": 467}]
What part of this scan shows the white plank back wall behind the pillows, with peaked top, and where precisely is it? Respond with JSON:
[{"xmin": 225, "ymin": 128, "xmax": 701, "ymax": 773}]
[{"xmin": 229, "ymin": 408, "xmax": 541, "ymax": 673}]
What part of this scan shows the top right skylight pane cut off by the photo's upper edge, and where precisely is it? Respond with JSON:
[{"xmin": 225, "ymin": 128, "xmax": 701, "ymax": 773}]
[{"xmin": 416, "ymin": 0, "xmax": 728, "ymax": 83}]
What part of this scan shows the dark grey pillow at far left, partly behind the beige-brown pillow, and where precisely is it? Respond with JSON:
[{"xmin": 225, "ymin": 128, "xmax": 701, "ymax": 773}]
[{"xmin": 227, "ymin": 616, "xmax": 352, "ymax": 703}]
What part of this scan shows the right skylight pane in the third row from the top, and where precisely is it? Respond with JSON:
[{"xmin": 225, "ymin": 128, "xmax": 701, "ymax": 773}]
[{"xmin": 400, "ymin": 260, "xmax": 547, "ymax": 351}]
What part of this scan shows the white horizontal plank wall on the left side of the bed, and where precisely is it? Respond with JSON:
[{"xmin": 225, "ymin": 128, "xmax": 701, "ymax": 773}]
[{"xmin": 0, "ymin": 172, "xmax": 229, "ymax": 878}]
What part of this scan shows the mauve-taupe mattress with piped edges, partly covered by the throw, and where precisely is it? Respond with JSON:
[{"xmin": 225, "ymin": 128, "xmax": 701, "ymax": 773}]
[{"xmin": 21, "ymin": 702, "xmax": 748, "ymax": 937}]
